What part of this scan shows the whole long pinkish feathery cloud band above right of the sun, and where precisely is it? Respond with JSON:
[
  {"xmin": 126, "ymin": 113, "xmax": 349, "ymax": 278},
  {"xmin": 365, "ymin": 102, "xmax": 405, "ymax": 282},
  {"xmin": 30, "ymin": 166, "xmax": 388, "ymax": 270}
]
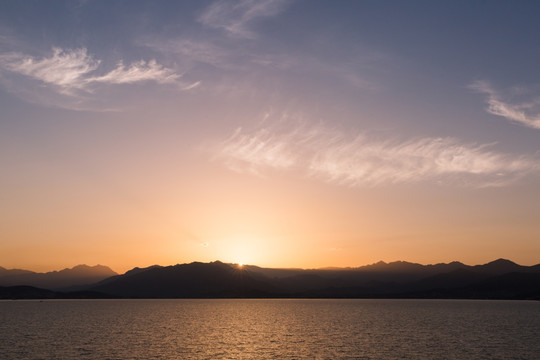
[{"xmin": 216, "ymin": 121, "xmax": 540, "ymax": 187}]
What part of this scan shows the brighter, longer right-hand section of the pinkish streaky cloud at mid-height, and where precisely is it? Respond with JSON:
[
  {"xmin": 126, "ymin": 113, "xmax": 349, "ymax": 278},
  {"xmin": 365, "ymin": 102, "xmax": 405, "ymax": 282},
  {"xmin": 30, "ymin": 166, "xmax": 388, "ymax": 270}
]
[{"xmin": 310, "ymin": 135, "xmax": 537, "ymax": 186}]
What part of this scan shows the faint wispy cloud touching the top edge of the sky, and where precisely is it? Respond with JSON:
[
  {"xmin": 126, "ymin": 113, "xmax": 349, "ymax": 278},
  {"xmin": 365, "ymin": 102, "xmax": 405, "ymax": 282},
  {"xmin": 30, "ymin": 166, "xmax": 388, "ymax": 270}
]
[{"xmin": 198, "ymin": 0, "xmax": 289, "ymax": 38}]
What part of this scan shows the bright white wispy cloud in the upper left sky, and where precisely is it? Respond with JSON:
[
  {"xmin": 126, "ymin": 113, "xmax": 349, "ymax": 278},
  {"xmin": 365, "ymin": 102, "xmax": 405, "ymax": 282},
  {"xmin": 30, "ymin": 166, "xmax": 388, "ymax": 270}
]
[{"xmin": 0, "ymin": 48, "xmax": 191, "ymax": 100}]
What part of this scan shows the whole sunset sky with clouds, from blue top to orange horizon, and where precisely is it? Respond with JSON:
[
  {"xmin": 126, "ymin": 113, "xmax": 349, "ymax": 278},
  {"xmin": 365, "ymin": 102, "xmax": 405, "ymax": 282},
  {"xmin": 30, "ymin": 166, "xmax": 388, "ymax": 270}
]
[{"xmin": 0, "ymin": 0, "xmax": 540, "ymax": 272}]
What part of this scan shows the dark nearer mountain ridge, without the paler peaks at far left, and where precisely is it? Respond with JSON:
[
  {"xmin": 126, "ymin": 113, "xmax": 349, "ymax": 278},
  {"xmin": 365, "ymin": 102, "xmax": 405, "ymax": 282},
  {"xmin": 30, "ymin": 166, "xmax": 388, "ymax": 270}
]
[{"xmin": 80, "ymin": 259, "xmax": 540, "ymax": 299}]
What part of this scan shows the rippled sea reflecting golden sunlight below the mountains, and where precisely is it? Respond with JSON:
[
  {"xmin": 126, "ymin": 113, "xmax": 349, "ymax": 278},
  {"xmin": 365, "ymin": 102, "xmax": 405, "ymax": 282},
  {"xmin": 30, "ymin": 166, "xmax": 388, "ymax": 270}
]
[{"xmin": 0, "ymin": 299, "xmax": 540, "ymax": 360}]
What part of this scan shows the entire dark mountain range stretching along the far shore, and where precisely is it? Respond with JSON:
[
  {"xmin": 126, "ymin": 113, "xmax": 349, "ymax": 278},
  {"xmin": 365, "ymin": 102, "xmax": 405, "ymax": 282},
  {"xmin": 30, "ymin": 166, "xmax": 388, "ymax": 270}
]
[{"xmin": 0, "ymin": 259, "xmax": 540, "ymax": 300}]
